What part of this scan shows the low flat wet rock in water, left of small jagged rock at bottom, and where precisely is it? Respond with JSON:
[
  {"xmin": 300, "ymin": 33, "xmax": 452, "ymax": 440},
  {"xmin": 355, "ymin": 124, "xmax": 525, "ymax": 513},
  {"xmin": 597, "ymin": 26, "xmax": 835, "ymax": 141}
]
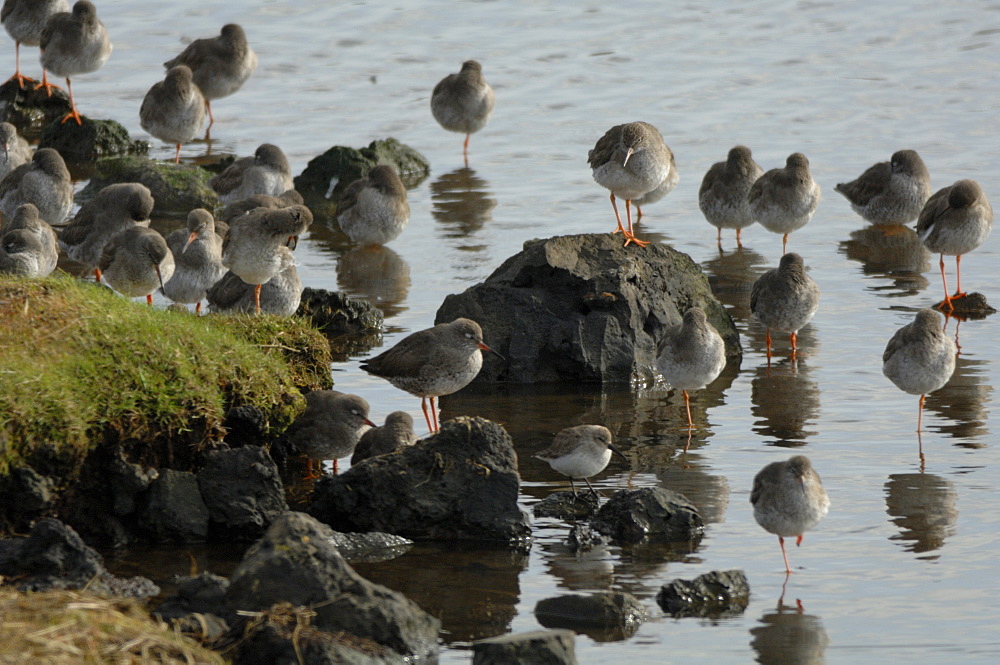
[{"xmin": 535, "ymin": 591, "xmax": 649, "ymax": 642}]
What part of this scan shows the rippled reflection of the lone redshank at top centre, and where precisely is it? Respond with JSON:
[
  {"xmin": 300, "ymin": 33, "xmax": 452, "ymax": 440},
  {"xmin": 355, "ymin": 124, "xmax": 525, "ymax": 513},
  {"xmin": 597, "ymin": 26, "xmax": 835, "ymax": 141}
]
[{"xmin": 431, "ymin": 168, "xmax": 497, "ymax": 238}]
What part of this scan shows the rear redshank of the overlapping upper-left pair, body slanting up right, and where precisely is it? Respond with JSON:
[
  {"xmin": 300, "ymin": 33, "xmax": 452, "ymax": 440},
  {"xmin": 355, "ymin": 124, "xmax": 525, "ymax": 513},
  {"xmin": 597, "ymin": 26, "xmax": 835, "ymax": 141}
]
[{"xmin": 163, "ymin": 23, "xmax": 257, "ymax": 136}]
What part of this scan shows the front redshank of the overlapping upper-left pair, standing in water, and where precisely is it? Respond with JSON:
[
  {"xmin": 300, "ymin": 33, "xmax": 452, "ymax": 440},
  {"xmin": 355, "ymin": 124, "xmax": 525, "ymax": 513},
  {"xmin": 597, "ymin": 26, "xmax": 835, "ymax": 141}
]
[{"xmin": 139, "ymin": 65, "xmax": 205, "ymax": 164}]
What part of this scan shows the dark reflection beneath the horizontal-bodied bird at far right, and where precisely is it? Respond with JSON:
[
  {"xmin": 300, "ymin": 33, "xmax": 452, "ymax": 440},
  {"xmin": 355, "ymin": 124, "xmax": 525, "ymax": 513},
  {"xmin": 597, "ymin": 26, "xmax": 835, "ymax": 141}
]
[{"xmin": 840, "ymin": 226, "xmax": 931, "ymax": 297}]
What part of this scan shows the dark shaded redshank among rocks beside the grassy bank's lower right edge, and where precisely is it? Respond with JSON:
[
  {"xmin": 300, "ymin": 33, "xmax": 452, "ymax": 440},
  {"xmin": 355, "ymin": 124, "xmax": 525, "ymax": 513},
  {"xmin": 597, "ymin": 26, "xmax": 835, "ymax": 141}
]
[{"xmin": 286, "ymin": 390, "xmax": 375, "ymax": 478}]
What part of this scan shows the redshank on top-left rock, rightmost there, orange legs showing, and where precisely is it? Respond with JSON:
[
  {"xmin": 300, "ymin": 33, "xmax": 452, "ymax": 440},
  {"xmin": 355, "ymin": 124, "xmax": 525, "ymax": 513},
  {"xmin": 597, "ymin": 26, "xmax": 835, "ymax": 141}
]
[{"xmin": 39, "ymin": 0, "xmax": 111, "ymax": 125}]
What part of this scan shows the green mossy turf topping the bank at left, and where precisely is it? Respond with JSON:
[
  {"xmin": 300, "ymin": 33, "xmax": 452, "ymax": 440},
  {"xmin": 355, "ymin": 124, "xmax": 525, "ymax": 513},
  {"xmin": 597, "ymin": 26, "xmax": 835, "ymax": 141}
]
[{"xmin": 0, "ymin": 276, "xmax": 330, "ymax": 479}]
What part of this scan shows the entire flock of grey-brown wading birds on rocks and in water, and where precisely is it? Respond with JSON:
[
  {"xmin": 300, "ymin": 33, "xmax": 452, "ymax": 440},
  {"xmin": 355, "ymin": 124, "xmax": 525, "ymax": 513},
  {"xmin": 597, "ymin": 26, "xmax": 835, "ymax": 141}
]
[{"xmin": 0, "ymin": 0, "xmax": 993, "ymax": 572}]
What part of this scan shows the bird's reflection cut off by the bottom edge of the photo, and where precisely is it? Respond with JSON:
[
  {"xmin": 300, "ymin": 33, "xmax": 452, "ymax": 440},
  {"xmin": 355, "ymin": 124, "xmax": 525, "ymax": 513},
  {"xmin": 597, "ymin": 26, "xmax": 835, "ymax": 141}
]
[{"xmin": 750, "ymin": 604, "xmax": 830, "ymax": 665}]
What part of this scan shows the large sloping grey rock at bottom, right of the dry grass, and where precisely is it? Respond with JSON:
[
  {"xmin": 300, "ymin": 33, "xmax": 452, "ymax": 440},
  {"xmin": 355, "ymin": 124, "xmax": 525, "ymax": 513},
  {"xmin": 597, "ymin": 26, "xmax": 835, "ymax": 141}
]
[{"xmin": 226, "ymin": 512, "xmax": 441, "ymax": 661}]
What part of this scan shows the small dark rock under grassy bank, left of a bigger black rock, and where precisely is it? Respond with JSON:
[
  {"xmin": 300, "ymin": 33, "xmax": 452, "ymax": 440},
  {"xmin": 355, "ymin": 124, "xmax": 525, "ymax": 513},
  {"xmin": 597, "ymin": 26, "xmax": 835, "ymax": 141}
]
[{"xmin": 142, "ymin": 469, "xmax": 208, "ymax": 543}]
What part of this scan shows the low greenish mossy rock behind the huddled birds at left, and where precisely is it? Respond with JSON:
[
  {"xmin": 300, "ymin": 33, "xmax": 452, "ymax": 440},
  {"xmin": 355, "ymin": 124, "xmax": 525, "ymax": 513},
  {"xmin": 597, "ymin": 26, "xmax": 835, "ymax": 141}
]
[{"xmin": 76, "ymin": 155, "xmax": 219, "ymax": 217}]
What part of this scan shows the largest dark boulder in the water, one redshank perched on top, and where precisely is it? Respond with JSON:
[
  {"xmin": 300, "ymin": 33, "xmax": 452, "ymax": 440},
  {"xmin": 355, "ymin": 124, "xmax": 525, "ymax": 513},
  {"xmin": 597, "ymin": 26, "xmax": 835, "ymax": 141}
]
[{"xmin": 434, "ymin": 233, "xmax": 742, "ymax": 383}]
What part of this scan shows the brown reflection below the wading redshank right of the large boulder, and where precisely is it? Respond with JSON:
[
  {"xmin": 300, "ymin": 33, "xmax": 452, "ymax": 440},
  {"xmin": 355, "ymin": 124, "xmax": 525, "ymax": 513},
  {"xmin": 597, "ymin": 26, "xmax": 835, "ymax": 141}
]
[{"xmin": 750, "ymin": 358, "xmax": 819, "ymax": 447}]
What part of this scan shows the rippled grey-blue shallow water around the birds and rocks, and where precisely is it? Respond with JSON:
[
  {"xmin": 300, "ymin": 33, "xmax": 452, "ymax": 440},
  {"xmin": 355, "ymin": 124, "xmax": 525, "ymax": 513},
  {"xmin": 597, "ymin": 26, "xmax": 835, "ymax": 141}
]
[{"xmin": 39, "ymin": 0, "xmax": 1000, "ymax": 663}]
